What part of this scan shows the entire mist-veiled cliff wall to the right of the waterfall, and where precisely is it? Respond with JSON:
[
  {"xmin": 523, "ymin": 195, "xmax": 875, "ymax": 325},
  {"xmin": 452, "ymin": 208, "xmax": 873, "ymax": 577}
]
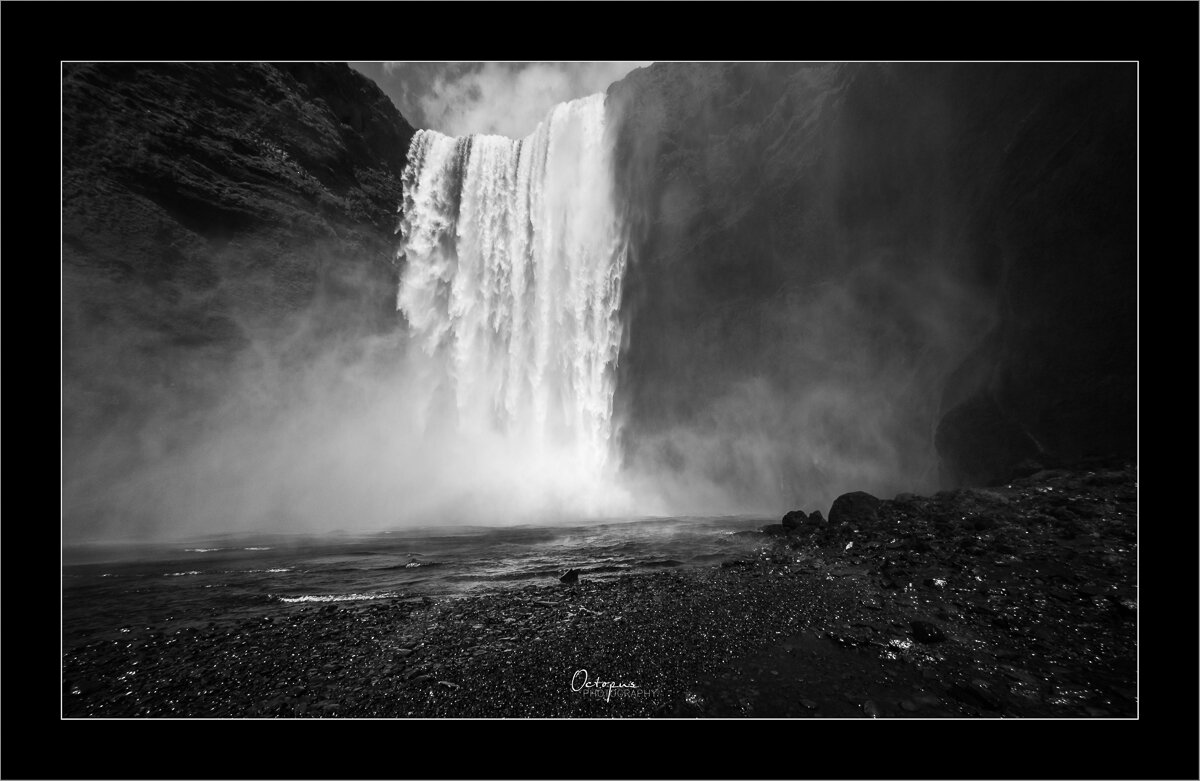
[{"xmin": 608, "ymin": 64, "xmax": 1136, "ymax": 506}]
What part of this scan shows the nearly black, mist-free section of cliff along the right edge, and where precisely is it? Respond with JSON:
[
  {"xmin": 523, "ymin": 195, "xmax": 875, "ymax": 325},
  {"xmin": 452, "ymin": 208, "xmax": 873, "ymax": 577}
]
[{"xmin": 936, "ymin": 65, "xmax": 1138, "ymax": 483}]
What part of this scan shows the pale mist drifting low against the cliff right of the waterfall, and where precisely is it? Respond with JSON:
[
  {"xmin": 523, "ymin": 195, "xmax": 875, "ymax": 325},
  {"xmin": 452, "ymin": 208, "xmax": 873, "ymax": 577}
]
[{"xmin": 623, "ymin": 253, "xmax": 992, "ymax": 517}]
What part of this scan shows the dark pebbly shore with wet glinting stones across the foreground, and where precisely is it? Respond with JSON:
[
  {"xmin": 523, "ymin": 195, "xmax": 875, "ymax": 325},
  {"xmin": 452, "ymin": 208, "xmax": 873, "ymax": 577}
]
[{"xmin": 62, "ymin": 463, "xmax": 1138, "ymax": 717}]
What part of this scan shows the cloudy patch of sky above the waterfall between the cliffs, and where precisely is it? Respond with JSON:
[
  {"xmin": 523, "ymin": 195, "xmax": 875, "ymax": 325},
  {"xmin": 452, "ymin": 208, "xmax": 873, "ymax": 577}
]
[{"xmin": 349, "ymin": 62, "xmax": 649, "ymax": 138}]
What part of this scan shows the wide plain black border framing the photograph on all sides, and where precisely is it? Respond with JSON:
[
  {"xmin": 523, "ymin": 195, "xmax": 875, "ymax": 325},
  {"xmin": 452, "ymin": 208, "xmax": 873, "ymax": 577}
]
[{"xmin": 9, "ymin": 0, "xmax": 1200, "ymax": 779}]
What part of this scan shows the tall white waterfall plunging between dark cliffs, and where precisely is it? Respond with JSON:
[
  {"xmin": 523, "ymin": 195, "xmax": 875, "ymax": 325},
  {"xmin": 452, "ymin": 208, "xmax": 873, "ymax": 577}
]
[{"xmin": 397, "ymin": 94, "xmax": 628, "ymax": 511}]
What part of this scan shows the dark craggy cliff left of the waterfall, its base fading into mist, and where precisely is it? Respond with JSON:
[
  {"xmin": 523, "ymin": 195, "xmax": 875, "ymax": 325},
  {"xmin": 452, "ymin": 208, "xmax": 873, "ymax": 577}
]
[{"xmin": 62, "ymin": 64, "xmax": 413, "ymax": 537}]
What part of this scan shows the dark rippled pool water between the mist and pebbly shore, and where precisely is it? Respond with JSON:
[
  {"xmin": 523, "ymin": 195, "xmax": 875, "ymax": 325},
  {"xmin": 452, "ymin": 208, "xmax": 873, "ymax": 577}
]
[{"xmin": 62, "ymin": 516, "xmax": 767, "ymax": 647}]
